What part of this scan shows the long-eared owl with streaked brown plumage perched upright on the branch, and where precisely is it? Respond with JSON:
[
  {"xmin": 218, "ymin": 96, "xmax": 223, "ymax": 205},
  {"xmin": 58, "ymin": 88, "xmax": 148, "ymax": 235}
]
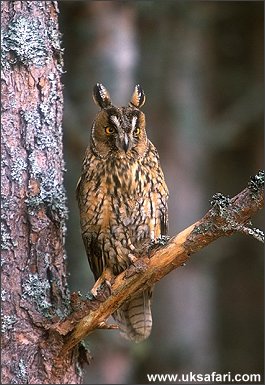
[{"xmin": 77, "ymin": 83, "xmax": 168, "ymax": 342}]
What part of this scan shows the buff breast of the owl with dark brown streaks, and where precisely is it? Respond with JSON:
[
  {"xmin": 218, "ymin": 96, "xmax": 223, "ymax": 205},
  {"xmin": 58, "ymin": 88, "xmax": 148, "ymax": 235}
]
[{"xmin": 79, "ymin": 143, "xmax": 167, "ymax": 270}]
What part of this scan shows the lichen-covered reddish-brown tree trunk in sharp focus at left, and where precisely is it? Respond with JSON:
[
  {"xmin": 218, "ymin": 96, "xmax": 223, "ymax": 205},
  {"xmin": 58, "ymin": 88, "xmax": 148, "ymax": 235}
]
[{"xmin": 1, "ymin": 1, "xmax": 81, "ymax": 384}]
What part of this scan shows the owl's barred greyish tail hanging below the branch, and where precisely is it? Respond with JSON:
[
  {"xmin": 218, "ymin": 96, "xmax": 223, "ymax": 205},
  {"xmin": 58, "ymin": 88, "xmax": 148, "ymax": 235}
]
[{"xmin": 113, "ymin": 288, "xmax": 152, "ymax": 342}]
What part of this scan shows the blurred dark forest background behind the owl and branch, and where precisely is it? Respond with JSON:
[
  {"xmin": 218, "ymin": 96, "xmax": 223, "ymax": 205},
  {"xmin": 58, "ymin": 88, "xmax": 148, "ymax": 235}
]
[{"xmin": 59, "ymin": 1, "xmax": 263, "ymax": 384}]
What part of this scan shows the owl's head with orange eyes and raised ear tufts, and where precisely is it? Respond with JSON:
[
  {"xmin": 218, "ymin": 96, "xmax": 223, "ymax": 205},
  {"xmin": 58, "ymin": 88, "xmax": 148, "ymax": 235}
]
[{"xmin": 91, "ymin": 83, "xmax": 147, "ymax": 158}]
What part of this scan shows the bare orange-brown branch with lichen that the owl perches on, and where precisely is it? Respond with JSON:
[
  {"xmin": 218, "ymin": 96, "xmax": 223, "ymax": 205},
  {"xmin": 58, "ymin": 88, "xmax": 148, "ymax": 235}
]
[{"xmin": 57, "ymin": 171, "xmax": 264, "ymax": 354}]
